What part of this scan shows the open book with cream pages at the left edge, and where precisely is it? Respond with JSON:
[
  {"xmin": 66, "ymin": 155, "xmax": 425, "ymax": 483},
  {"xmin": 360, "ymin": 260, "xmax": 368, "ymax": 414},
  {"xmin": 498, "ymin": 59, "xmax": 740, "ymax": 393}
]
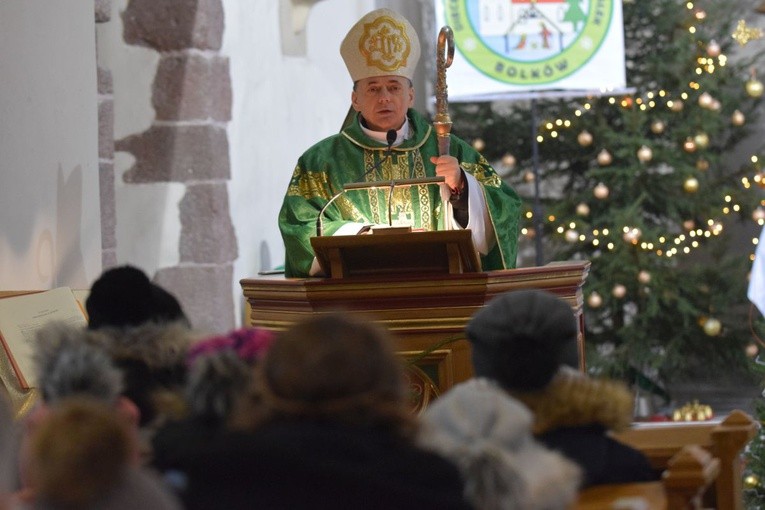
[{"xmin": 0, "ymin": 287, "xmax": 87, "ymax": 390}]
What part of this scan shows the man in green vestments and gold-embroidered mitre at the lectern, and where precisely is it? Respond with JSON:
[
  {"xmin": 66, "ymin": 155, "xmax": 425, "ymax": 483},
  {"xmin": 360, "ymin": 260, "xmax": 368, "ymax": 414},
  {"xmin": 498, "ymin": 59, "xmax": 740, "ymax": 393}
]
[{"xmin": 279, "ymin": 5, "xmax": 520, "ymax": 277}]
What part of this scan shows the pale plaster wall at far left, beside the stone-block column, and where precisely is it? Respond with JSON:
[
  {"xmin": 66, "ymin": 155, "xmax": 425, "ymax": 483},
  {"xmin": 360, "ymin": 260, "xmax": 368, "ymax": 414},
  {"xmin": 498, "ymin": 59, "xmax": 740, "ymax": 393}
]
[{"xmin": 0, "ymin": 0, "xmax": 101, "ymax": 290}]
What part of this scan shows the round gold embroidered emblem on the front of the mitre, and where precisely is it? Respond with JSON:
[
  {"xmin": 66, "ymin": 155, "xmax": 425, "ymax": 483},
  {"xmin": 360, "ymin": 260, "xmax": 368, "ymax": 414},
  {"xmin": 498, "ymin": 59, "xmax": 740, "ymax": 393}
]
[{"xmin": 359, "ymin": 16, "xmax": 411, "ymax": 71}]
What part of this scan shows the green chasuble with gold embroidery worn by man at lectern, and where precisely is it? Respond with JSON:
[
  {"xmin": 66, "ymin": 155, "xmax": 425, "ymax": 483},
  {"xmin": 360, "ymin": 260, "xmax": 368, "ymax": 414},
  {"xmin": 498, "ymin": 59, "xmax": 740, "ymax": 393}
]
[{"xmin": 279, "ymin": 109, "xmax": 521, "ymax": 277}]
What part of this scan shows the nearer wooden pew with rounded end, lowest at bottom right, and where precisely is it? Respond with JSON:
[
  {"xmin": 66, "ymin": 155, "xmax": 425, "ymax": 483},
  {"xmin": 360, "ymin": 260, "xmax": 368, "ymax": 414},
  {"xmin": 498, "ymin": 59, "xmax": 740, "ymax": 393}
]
[{"xmin": 574, "ymin": 445, "xmax": 721, "ymax": 510}]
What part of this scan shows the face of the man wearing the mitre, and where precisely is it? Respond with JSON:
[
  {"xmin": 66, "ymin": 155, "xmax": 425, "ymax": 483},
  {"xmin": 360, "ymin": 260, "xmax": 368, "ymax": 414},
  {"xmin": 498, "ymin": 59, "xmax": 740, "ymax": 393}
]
[{"xmin": 351, "ymin": 76, "xmax": 414, "ymax": 131}]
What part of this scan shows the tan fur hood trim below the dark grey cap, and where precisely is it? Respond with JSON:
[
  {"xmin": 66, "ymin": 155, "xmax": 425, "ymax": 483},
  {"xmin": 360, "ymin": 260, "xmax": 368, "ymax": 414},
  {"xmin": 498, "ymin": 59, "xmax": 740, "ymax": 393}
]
[{"xmin": 510, "ymin": 367, "xmax": 634, "ymax": 435}]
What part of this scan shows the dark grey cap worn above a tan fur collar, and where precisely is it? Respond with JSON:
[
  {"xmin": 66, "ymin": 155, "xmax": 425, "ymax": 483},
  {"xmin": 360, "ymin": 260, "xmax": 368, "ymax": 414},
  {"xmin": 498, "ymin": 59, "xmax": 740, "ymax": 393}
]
[{"xmin": 466, "ymin": 290, "xmax": 579, "ymax": 391}]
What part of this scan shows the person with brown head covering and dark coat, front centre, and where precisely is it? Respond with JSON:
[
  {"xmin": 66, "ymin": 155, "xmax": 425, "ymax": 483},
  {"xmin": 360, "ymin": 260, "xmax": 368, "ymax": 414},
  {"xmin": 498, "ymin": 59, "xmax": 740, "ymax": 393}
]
[{"xmin": 171, "ymin": 313, "xmax": 470, "ymax": 510}]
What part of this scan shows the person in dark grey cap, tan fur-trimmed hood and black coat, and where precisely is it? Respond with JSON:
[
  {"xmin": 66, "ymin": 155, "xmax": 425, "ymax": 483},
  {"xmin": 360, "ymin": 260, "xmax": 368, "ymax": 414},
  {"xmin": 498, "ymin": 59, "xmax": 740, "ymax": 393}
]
[{"xmin": 466, "ymin": 290, "xmax": 657, "ymax": 487}]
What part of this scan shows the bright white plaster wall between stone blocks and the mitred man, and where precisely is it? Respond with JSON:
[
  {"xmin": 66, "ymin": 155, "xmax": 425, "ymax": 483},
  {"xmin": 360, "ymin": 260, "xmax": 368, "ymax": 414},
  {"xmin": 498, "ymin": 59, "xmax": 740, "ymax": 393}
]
[{"xmin": 223, "ymin": 0, "xmax": 375, "ymax": 317}]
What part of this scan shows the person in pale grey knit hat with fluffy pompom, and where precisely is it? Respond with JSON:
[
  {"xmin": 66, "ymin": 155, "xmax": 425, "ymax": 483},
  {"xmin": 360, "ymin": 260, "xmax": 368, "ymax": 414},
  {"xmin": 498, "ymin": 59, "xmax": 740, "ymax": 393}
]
[{"xmin": 419, "ymin": 378, "xmax": 581, "ymax": 510}]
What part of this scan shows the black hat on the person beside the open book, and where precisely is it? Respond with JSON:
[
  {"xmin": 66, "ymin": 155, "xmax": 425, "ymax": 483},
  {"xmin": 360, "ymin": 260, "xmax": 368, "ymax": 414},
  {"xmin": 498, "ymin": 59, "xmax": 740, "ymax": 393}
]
[{"xmin": 85, "ymin": 266, "xmax": 188, "ymax": 329}]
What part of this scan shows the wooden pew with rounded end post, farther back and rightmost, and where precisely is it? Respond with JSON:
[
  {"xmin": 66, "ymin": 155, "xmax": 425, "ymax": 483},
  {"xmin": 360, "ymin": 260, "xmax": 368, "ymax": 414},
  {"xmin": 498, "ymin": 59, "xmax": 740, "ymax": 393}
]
[{"xmin": 616, "ymin": 410, "xmax": 758, "ymax": 510}]
